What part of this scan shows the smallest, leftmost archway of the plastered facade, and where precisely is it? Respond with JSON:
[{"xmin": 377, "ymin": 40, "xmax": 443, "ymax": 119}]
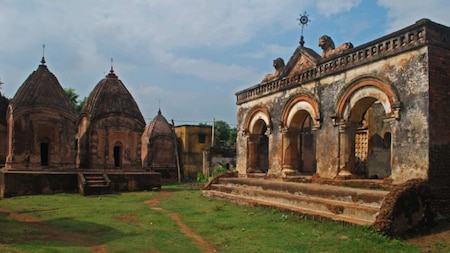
[{"xmin": 244, "ymin": 107, "xmax": 271, "ymax": 173}]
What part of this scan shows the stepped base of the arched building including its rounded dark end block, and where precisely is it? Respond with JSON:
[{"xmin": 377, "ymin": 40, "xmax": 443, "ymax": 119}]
[{"xmin": 202, "ymin": 173, "xmax": 432, "ymax": 235}]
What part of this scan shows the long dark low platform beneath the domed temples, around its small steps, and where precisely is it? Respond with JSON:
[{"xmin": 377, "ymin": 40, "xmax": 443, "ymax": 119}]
[{"xmin": 0, "ymin": 169, "xmax": 161, "ymax": 198}]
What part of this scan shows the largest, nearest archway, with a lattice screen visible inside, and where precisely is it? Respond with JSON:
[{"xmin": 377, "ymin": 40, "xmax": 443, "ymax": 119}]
[{"xmin": 332, "ymin": 78, "xmax": 400, "ymax": 178}]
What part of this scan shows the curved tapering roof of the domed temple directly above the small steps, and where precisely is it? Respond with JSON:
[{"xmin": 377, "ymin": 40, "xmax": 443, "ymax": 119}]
[{"xmin": 81, "ymin": 68, "xmax": 145, "ymax": 125}]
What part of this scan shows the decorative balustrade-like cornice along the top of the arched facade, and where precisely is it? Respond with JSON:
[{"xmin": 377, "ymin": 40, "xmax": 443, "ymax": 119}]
[{"xmin": 236, "ymin": 19, "xmax": 444, "ymax": 105}]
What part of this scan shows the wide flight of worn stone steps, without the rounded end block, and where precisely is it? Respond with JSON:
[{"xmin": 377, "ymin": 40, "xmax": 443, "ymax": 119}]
[{"xmin": 202, "ymin": 177, "xmax": 388, "ymax": 225}]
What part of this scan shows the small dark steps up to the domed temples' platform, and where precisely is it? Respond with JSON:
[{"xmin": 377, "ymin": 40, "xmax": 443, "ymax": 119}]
[{"xmin": 78, "ymin": 173, "xmax": 112, "ymax": 196}]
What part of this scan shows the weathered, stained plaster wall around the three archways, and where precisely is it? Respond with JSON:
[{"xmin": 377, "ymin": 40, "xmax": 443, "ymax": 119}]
[{"xmin": 237, "ymin": 47, "xmax": 429, "ymax": 183}]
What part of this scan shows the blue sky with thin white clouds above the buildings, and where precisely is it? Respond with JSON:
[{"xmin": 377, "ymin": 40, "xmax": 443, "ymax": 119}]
[{"xmin": 0, "ymin": 0, "xmax": 450, "ymax": 127}]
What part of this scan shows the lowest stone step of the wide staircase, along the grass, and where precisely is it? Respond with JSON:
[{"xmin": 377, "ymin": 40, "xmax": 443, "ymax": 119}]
[{"xmin": 203, "ymin": 190, "xmax": 373, "ymax": 225}]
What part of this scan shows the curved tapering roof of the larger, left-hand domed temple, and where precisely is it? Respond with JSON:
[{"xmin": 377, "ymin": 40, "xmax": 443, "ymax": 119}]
[{"xmin": 10, "ymin": 61, "xmax": 76, "ymax": 117}]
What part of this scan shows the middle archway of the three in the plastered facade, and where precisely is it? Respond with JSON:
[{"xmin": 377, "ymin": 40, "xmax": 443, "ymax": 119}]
[{"xmin": 281, "ymin": 94, "xmax": 320, "ymax": 176}]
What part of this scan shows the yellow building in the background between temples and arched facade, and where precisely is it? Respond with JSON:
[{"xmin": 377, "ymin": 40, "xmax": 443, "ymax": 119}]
[{"xmin": 175, "ymin": 125, "xmax": 212, "ymax": 179}]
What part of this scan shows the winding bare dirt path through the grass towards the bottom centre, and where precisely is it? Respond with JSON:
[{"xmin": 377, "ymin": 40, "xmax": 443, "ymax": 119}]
[{"xmin": 145, "ymin": 192, "xmax": 216, "ymax": 253}]
